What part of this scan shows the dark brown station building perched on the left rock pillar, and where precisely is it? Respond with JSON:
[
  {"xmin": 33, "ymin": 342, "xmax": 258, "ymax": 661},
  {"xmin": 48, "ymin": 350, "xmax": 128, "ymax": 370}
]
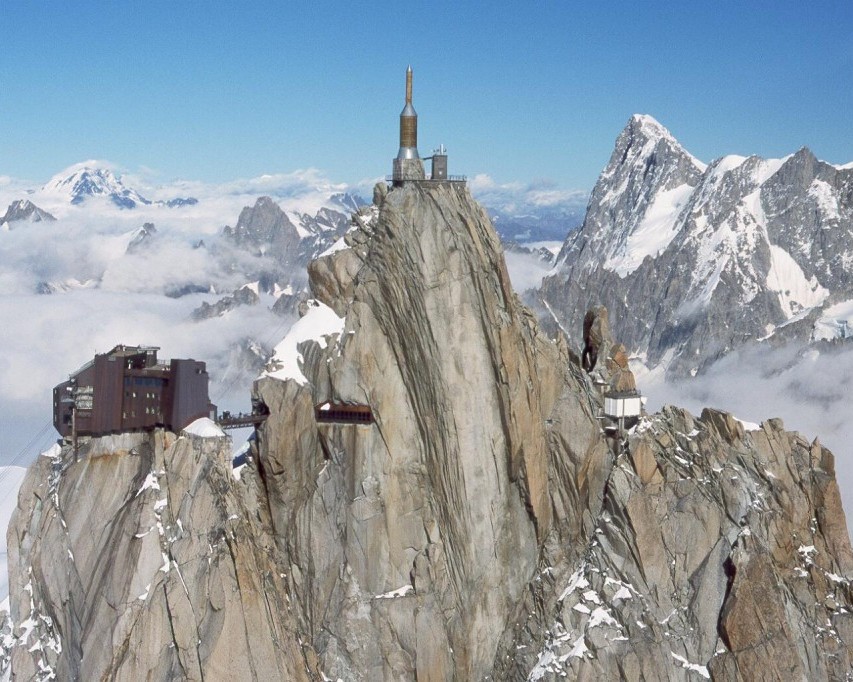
[{"xmin": 53, "ymin": 346, "xmax": 216, "ymax": 437}]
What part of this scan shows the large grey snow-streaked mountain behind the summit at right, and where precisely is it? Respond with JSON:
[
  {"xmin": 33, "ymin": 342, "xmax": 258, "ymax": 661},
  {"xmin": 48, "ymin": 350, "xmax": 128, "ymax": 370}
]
[{"xmin": 538, "ymin": 115, "xmax": 853, "ymax": 376}]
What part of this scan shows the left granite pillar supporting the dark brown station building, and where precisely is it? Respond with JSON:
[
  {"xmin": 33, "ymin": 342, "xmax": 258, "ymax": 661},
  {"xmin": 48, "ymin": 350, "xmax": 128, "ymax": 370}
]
[{"xmin": 7, "ymin": 431, "xmax": 316, "ymax": 680}]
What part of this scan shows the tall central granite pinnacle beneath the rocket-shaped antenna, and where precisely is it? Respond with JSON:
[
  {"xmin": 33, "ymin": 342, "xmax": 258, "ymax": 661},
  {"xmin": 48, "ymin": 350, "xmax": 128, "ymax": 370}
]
[{"xmin": 256, "ymin": 178, "xmax": 568, "ymax": 679}]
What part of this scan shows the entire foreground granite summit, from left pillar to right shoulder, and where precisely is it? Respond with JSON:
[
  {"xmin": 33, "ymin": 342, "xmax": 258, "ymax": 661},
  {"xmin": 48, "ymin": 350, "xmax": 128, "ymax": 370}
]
[{"xmin": 3, "ymin": 178, "xmax": 853, "ymax": 682}]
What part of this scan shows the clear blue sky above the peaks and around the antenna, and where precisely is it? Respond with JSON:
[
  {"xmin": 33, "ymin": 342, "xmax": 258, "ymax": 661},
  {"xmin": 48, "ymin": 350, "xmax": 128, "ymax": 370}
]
[{"xmin": 0, "ymin": 0, "xmax": 853, "ymax": 189}]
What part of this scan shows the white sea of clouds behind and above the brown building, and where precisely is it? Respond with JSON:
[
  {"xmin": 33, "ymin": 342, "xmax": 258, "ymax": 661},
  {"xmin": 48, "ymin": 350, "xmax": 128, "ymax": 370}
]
[{"xmin": 0, "ymin": 171, "xmax": 332, "ymax": 465}]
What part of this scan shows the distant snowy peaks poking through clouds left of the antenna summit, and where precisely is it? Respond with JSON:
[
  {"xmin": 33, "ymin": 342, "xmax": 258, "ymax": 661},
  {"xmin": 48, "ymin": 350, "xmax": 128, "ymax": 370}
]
[{"xmin": 0, "ymin": 162, "xmax": 365, "ymax": 302}]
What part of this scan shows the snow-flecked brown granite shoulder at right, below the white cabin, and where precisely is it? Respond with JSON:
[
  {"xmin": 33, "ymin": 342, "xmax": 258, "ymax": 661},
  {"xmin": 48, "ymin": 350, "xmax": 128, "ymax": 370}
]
[{"xmin": 497, "ymin": 408, "xmax": 853, "ymax": 681}]
